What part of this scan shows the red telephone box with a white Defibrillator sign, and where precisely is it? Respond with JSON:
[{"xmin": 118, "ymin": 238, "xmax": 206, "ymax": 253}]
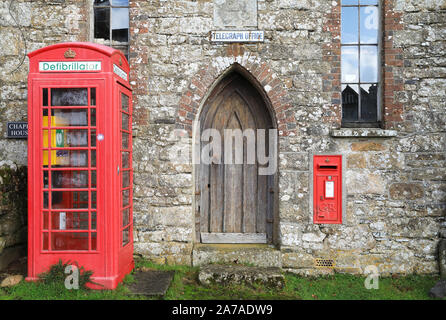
[{"xmin": 27, "ymin": 42, "xmax": 134, "ymax": 289}]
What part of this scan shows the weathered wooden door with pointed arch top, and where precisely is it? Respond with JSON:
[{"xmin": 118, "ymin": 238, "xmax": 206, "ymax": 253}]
[{"xmin": 196, "ymin": 73, "xmax": 274, "ymax": 243}]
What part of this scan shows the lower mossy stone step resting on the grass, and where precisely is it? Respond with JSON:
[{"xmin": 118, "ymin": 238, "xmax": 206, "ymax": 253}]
[{"xmin": 198, "ymin": 264, "xmax": 285, "ymax": 288}]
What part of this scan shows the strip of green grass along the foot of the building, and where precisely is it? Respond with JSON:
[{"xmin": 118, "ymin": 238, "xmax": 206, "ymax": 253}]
[{"xmin": 0, "ymin": 260, "xmax": 439, "ymax": 300}]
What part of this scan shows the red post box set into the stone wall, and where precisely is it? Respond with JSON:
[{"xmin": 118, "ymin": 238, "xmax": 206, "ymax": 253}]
[{"xmin": 313, "ymin": 155, "xmax": 342, "ymax": 224}]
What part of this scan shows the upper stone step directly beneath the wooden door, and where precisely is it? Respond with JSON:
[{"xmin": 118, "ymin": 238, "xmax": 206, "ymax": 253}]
[{"xmin": 192, "ymin": 243, "xmax": 282, "ymax": 268}]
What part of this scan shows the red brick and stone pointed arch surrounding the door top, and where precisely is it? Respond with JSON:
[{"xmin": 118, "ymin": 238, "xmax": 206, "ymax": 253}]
[{"xmin": 175, "ymin": 44, "xmax": 296, "ymax": 136}]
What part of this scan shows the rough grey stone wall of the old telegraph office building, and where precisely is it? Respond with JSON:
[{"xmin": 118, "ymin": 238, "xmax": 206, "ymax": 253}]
[{"xmin": 0, "ymin": 0, "xmax": 446, "ymax": 274}]
